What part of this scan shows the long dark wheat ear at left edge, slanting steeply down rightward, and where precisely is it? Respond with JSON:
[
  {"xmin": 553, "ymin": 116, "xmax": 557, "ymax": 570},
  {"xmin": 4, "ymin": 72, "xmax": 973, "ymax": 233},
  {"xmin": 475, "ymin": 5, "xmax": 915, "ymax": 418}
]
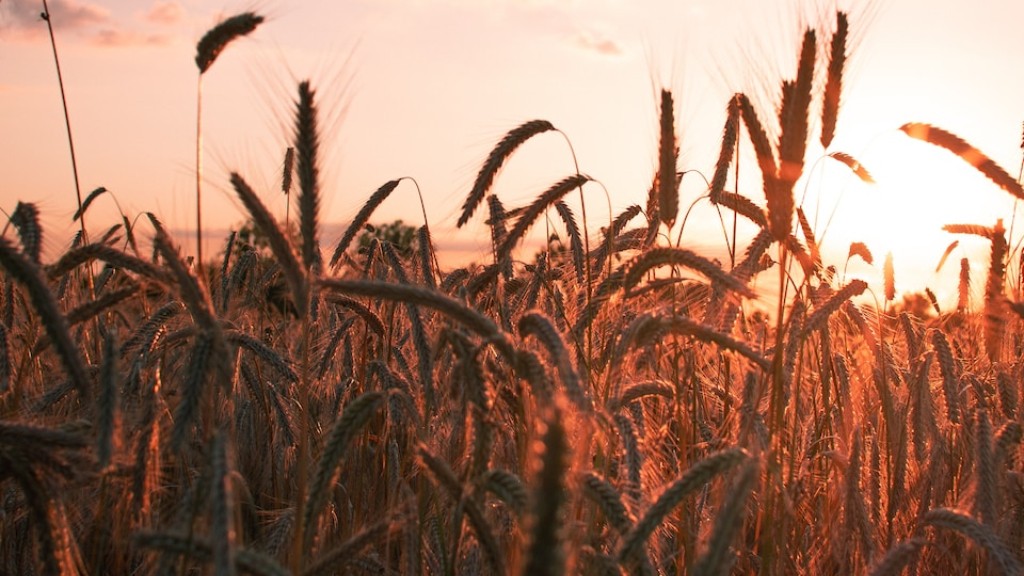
[{"xmin": 0, "ymin": 238, "xmax": 91, "ymax": 393}]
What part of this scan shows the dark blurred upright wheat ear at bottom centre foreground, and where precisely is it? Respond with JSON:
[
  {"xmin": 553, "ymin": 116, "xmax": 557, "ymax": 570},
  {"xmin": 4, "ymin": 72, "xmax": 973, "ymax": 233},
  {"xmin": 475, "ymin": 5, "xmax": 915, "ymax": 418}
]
[{"xmin": 523, "ymin": 401, "xmax": 569, "ymax": 576}]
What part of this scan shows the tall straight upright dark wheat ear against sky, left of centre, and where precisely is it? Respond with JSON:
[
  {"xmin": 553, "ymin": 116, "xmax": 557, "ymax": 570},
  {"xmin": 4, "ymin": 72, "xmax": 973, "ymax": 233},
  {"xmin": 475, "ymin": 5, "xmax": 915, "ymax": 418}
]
[{"xmin": 294, "ymin": 80, "xmax": 319, "ymax": 270}]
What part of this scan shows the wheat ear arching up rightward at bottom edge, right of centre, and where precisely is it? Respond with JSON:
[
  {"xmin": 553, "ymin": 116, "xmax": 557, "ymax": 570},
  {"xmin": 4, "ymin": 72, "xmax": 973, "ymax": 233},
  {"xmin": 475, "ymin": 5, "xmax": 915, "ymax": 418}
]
[{"xmin": 618, "ymin": 448, "xmax": 748, "ymax": 562}]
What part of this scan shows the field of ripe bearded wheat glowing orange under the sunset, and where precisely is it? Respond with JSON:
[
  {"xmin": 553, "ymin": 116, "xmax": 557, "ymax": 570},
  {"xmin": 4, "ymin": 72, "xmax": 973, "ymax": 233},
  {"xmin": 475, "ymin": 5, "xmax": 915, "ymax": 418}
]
[{"xmin": 6, "ymin": 8, "xmax": 1024, "ymax": 576}]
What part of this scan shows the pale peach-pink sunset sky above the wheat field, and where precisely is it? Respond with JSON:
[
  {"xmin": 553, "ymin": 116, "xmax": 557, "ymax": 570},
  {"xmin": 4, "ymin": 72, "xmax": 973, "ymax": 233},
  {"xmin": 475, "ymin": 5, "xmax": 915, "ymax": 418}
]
[{"xmin": 0, "ymin": 0, "xmax": 1024, "ymax": 303}]
